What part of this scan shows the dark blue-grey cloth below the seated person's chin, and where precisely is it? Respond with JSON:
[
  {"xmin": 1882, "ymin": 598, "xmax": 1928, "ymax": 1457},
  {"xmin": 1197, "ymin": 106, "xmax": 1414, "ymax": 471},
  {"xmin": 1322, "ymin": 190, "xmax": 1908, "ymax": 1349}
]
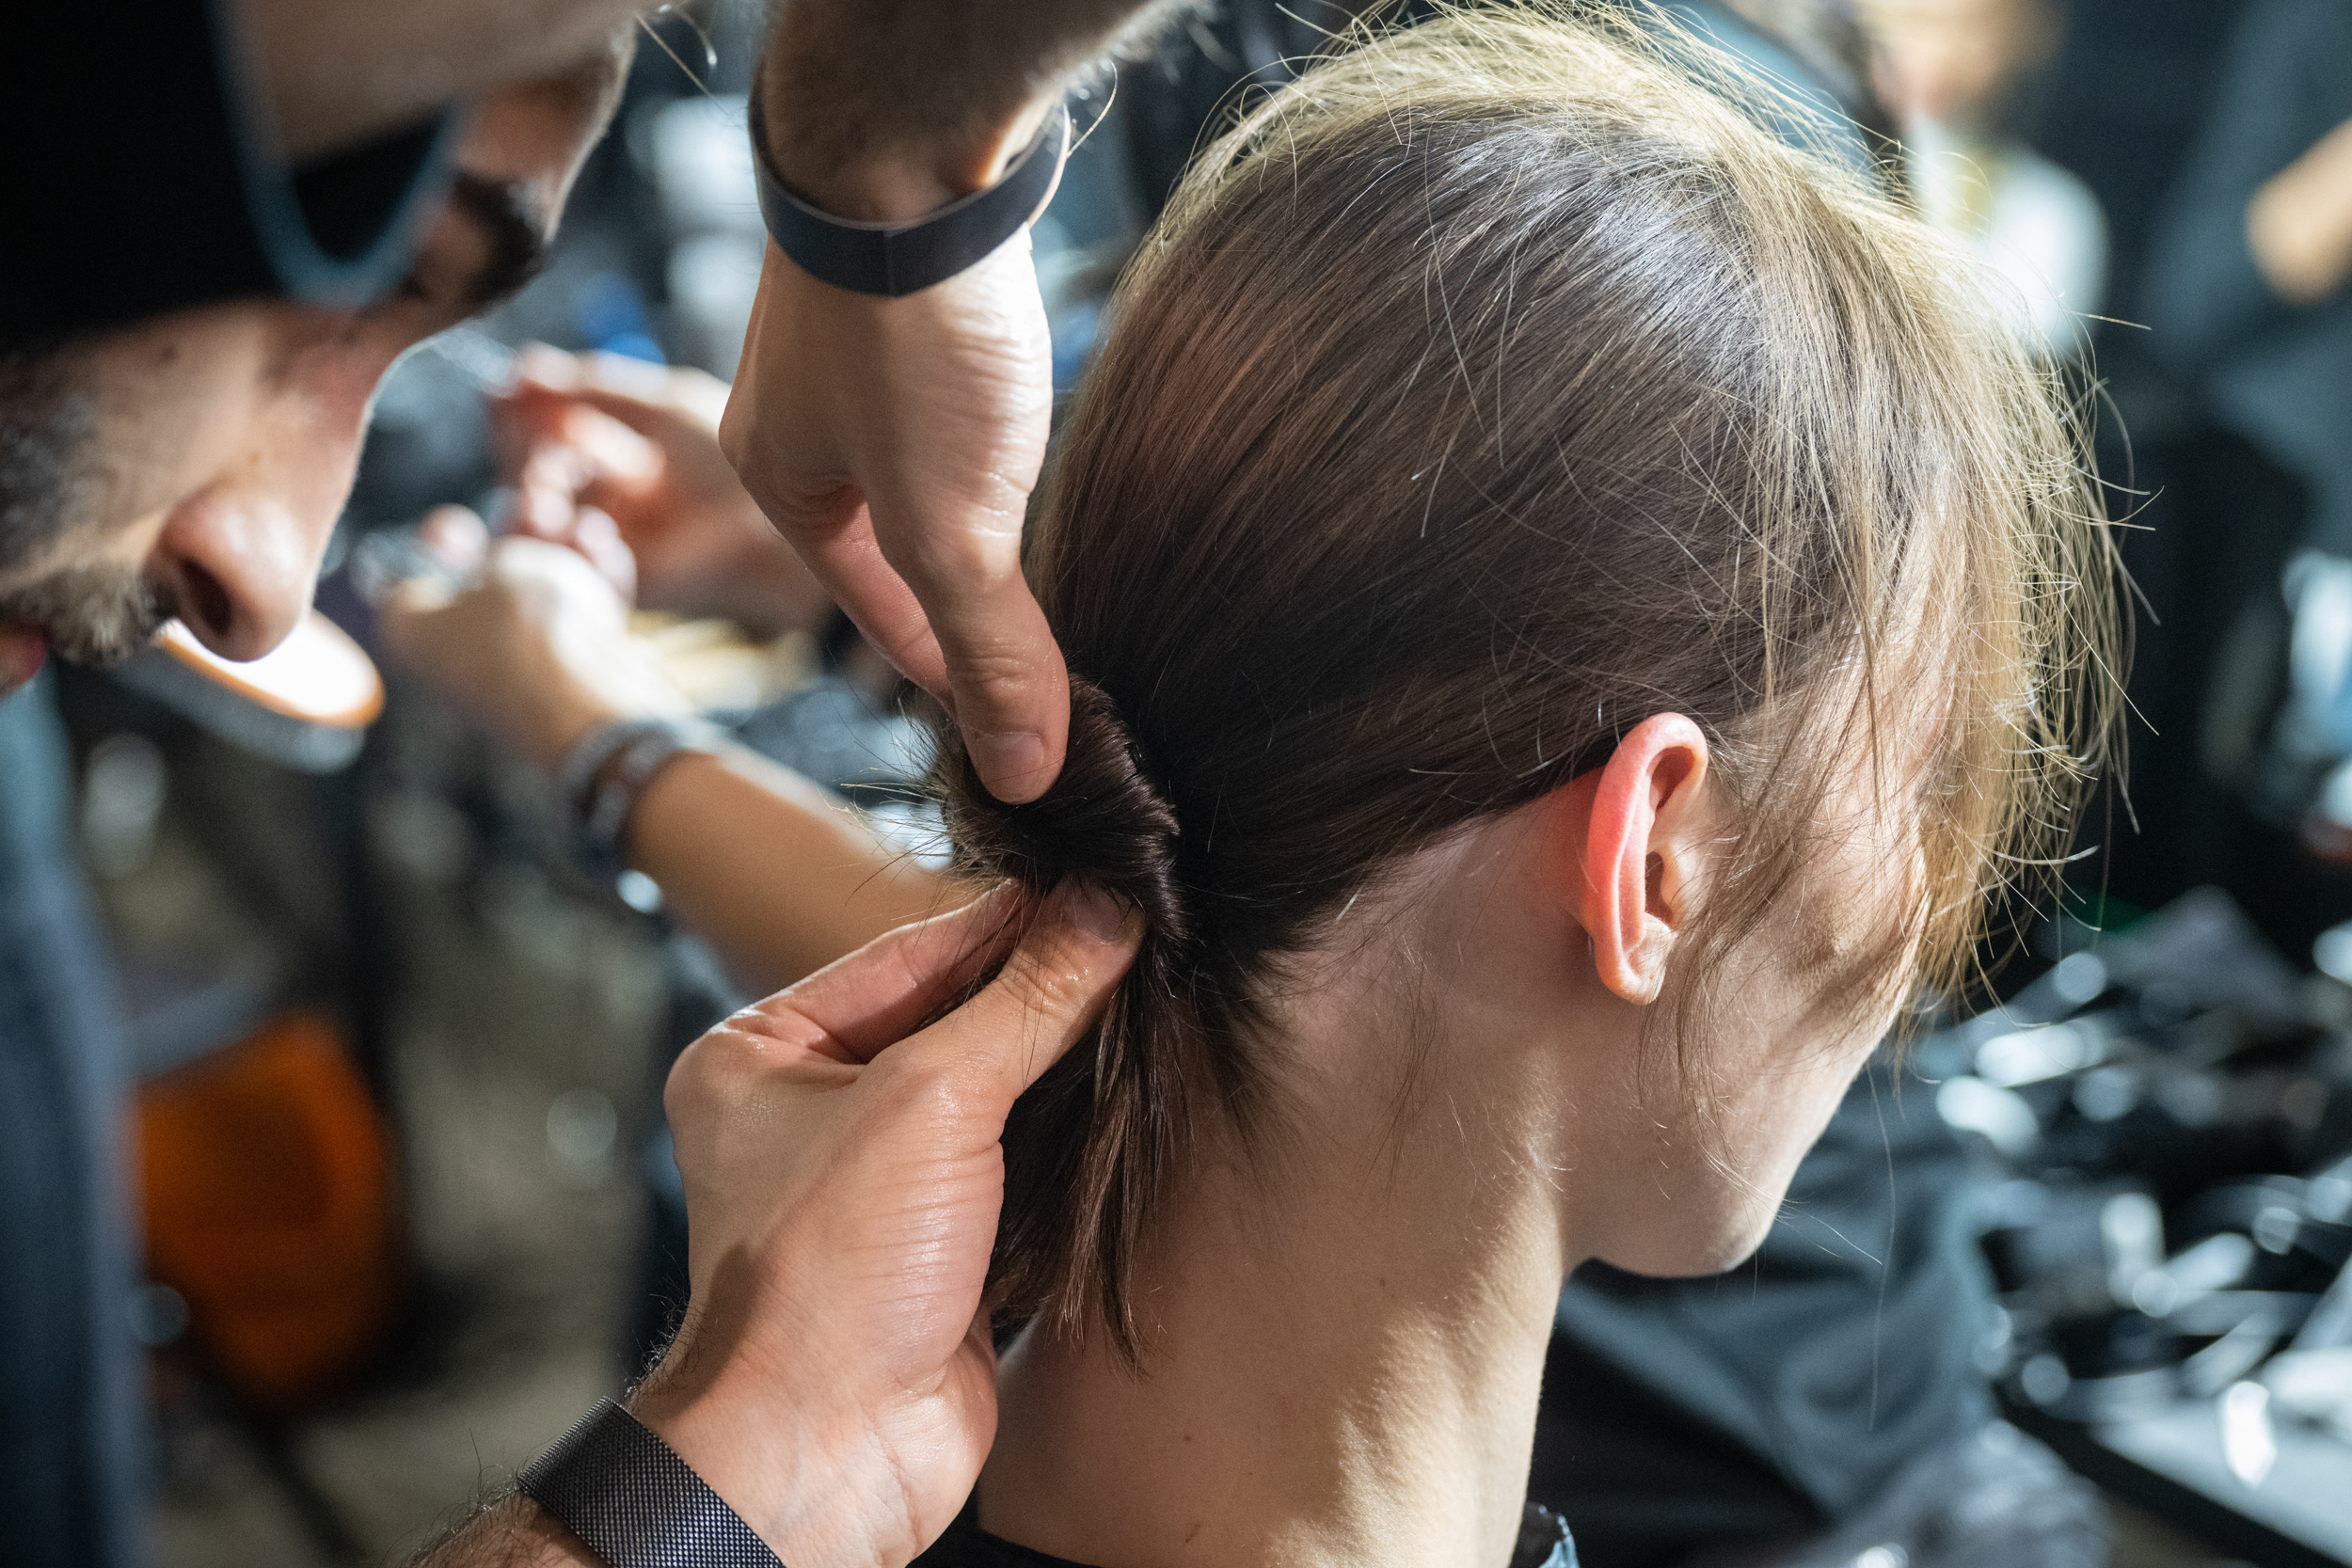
[{"xmin": 1529, "ymin": 1063, "xmax": 1993, "ymax": 1568}]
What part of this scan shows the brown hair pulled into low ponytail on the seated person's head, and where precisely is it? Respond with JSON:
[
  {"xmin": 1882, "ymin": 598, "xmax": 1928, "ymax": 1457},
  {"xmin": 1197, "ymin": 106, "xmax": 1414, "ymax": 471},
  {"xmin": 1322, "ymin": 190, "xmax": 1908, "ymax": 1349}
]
[{"xmin": 939, "ymin": 5, "xmax": 2115, "ymax": 1356}]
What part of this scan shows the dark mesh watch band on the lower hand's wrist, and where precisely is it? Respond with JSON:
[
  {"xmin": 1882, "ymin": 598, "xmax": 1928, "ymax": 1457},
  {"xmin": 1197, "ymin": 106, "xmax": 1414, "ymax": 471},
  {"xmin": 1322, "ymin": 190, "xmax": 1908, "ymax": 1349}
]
[{"xmin": 516, "ymin": 1399, "xmax": 784, "ymax": 1568}]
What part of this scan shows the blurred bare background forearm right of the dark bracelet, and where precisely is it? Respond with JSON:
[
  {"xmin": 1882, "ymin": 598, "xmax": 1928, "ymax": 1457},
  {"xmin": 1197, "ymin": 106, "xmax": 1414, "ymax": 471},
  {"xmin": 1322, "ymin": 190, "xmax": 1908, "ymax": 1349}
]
[{"xmin": 628, "ymin": 750, "xmax": 953, "ymax": 992}]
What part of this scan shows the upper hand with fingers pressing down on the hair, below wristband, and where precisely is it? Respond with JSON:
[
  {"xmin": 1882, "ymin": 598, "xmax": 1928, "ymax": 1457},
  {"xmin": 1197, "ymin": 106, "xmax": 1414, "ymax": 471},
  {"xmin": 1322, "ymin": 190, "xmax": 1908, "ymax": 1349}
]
[{"xmin": 720, "ymin": 232, "xmax": 1071, "ymax": 801}]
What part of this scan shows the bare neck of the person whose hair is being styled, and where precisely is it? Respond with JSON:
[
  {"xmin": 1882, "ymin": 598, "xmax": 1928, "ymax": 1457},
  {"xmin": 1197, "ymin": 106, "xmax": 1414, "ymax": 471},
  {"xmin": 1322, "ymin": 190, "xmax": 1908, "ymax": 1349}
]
[{"xmin": 981, "ymin": 991, "xmax": 1569, "ymax": 1568}]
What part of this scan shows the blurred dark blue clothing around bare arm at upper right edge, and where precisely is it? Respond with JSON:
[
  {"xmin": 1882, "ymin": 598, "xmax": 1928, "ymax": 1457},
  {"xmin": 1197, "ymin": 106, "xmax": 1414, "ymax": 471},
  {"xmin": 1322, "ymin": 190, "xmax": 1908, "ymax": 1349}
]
[{"xmin": 2145, "ymin": 0, "xmax": 2352, "ymax": 555}]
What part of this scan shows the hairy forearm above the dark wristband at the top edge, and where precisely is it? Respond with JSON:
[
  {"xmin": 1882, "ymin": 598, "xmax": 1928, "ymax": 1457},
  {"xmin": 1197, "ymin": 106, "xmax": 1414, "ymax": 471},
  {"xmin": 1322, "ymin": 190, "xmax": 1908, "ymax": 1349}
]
[{"xmin": 760, "ymin": 0, "xmax": 1181, "ymax": 221}]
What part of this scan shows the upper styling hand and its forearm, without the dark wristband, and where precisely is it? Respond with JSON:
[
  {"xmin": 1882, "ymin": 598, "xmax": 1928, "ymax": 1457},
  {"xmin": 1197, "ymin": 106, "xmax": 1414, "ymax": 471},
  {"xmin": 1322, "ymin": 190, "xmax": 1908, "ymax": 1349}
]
[{"xmin": 723, "ymin": 0, "xmax": 1179, "ymax": 800}]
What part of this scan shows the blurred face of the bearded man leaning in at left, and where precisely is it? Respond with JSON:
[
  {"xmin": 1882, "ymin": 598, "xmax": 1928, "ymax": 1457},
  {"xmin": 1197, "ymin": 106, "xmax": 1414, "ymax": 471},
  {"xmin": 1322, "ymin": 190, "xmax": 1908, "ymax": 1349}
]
[{"xmin": 0, "ymin": 49, "xmax": 626, "ymax": 693}]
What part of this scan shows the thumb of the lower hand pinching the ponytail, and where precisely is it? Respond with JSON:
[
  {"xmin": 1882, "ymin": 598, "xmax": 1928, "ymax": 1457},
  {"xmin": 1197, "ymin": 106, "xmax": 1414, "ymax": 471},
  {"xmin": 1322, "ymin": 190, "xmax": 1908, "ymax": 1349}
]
[{"xmin": 892, "ymin": 879, "xmax": 1143, "ymax": 1109}]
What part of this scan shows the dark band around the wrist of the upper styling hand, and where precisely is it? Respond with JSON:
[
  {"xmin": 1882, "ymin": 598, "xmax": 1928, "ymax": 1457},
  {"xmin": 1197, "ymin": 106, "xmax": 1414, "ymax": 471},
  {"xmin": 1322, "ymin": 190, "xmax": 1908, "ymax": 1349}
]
[{"xmin": 751, "ymin": 93, "xmax": 1071, "ymax": 298}]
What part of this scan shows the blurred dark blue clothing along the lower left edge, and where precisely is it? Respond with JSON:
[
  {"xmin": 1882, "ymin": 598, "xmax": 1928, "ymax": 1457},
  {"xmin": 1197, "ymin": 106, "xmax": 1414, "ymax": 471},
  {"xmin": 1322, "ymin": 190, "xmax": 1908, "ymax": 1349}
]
[{"xmin": 0, "ymin": 684, "xmax": 146, "ymax": 1568}]
